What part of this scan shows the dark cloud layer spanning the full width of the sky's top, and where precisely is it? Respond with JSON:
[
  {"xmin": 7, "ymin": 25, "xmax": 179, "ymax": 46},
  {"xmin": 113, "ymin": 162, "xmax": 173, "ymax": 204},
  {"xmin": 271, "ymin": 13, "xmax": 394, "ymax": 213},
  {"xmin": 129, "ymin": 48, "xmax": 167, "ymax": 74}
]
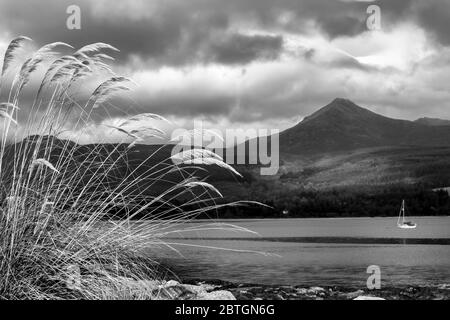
[{"xmin": 0, "ymin": 0, "xmax": 450, "ymax": 66}]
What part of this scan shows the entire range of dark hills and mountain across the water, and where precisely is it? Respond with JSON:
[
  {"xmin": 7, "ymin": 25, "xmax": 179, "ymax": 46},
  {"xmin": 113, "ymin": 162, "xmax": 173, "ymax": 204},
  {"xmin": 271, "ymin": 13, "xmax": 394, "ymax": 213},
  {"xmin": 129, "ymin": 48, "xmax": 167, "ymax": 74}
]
[{"xmin": 4, "ymin": 99, "xmax": 450, "ymax": 217}]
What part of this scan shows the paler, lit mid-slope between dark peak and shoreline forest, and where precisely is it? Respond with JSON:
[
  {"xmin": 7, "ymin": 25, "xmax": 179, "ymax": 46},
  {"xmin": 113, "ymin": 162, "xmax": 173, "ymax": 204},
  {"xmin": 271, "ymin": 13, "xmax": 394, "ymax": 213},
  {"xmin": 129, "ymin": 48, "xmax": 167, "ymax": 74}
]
[{"xmin": 279, "ymin": 147, "xmax": 450, "ymax": 189}]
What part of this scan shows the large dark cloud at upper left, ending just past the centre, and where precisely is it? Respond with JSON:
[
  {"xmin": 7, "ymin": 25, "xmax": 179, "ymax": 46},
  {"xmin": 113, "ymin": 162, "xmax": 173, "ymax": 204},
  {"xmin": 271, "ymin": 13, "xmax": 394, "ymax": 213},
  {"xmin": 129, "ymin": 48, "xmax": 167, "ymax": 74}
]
[{"xmin": 0, "ymin": 0, "xmax": 282, "ymax": 67}]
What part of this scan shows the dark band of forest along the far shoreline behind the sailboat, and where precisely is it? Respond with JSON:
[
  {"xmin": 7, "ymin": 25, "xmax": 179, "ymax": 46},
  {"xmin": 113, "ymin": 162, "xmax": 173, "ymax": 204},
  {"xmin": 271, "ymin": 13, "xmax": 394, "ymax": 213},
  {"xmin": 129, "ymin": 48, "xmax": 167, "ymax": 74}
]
[{"xmin": 211, "ymin": 185, "xmax": 450, "ymax": 218}]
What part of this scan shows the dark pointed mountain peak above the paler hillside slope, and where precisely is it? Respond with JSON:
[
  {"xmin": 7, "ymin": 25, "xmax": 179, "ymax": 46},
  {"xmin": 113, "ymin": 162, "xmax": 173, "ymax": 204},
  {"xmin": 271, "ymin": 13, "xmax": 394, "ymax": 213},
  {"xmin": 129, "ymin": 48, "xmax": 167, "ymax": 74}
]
[{"xmin": 280, "ymin": 98, "xmax": 450, "ymax": 154}]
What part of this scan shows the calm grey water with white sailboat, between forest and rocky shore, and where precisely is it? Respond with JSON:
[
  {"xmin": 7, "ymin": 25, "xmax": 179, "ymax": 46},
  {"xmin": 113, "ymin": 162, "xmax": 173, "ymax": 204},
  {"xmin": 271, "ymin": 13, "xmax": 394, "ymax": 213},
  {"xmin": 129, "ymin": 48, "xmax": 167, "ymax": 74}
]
[{"xmin": 143, "ymin": 217, "xmax": 450, "ymax": 287}]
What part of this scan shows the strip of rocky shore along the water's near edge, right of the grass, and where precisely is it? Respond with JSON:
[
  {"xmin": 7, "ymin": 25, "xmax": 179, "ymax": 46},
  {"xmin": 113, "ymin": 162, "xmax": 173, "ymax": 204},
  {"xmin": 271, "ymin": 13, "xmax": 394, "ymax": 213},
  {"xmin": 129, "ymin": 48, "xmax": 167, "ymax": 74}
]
[{"xmin": 160, "ymin": 280, "xmax": 450, "ymax": 300}]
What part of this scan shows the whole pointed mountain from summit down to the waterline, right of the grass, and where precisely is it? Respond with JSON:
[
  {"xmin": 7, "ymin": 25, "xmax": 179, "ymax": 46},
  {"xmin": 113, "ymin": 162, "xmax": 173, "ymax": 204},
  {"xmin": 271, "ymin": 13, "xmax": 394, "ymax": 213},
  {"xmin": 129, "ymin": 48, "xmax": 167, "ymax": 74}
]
[{"xmin": 216, "ymin": 99, "xmax": 450, "ymax": 217}]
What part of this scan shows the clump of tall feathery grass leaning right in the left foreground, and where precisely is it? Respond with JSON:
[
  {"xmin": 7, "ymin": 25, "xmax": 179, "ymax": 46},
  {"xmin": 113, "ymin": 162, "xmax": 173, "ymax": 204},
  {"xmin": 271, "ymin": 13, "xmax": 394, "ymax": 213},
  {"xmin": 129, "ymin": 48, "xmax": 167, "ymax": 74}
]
[{"xmin": 0, "ymin": 37, "xmax": 250, "ymax": 299}]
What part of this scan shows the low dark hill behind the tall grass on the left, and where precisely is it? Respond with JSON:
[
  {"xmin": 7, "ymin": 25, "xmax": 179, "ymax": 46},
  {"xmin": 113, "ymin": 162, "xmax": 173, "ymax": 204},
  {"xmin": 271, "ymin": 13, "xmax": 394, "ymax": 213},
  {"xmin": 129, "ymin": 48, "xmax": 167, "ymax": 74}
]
[{"xmin": 0, "ymin": 135, "xmax": 242, "ymax": 198}]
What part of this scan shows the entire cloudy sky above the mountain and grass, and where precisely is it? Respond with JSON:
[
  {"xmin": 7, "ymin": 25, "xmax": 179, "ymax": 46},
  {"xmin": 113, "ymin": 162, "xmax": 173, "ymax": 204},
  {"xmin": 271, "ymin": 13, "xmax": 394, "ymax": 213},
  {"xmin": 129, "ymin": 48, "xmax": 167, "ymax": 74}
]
[{"xmin": 0, "ymin": 0, "xmax": 450, "ymax": 141}]
